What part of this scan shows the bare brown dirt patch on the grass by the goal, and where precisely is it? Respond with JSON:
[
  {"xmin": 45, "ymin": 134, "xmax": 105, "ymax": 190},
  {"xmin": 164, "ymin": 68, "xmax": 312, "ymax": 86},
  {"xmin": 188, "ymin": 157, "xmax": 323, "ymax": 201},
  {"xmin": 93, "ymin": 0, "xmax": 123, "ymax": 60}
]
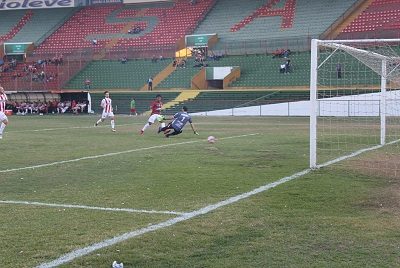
[{"xmin": 348, "ymin": 153, "xmax": 400, "ymax": 216}]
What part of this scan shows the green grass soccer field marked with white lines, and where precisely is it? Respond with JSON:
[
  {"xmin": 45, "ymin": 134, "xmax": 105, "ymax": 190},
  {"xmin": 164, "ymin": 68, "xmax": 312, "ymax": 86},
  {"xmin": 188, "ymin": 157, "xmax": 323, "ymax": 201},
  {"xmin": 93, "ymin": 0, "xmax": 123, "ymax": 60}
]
[{"xmin": 0, "ymin": 116, "xmax": 400, "ymax": 267}]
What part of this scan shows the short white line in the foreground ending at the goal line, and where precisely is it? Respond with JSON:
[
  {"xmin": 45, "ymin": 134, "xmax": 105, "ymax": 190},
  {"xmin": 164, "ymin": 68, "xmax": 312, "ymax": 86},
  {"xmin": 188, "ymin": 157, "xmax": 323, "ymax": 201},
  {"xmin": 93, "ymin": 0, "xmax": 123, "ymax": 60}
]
[{"xmin": 0, "ymin": 200, "xmax": 184, "ymax": 215}]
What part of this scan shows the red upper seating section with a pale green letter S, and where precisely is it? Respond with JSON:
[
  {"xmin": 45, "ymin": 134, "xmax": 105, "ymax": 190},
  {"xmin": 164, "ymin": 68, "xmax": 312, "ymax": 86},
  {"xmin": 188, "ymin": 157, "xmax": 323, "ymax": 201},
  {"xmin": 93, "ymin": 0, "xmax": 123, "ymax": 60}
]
[{"xmin": 37, "ymin": 0, "xmax": 214, "ymax": 52}]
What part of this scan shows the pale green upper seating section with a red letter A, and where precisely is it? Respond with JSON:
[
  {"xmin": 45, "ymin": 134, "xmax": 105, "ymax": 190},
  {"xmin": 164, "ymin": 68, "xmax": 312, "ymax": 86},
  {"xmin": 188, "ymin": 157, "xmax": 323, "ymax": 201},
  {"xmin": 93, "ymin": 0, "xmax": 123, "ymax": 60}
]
[{"xmin": 195, "ymin": 0, "xmax": 357, "ymax": 46}]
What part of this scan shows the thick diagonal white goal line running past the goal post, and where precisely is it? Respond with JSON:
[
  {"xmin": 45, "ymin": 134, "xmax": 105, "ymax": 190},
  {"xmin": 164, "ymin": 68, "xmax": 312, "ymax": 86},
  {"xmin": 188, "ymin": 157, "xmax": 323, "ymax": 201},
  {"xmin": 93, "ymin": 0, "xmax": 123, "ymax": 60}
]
[{"xmin": 37, "ymin": 140, "xmax": 400, "ymax": 268}]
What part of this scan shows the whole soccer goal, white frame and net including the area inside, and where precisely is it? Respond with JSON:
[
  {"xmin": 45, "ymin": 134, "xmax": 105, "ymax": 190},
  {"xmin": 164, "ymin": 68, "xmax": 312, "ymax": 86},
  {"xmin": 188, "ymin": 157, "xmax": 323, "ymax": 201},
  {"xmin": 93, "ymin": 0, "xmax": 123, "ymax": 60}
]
[{"xmin": 310, "ymin": 39, "xmax": 400, "ymax": 176}]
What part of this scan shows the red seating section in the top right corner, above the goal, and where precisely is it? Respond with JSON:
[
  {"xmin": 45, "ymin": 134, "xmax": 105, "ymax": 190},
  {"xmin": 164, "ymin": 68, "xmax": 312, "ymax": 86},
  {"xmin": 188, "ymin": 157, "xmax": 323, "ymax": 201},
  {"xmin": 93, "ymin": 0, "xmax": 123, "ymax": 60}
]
[{"xmin": 337, "ymin": 0, "xmax": 400, "ymax": 39}]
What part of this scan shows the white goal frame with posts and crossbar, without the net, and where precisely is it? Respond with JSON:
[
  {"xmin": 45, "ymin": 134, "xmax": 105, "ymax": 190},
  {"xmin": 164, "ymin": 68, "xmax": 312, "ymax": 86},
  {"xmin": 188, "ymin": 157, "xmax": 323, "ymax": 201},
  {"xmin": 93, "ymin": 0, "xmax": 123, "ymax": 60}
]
[{"xmin": 310, "ymin": 39, "xmax": 400, "ymax": 169}]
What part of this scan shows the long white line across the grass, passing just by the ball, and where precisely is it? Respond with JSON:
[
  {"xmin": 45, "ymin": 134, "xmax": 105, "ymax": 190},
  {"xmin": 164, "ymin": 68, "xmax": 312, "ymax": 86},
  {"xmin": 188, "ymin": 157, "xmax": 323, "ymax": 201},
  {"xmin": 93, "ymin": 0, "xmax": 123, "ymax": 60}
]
[{"xmin": 0, "ymin": 133, "xmax": 259, "ymax": 173}]
